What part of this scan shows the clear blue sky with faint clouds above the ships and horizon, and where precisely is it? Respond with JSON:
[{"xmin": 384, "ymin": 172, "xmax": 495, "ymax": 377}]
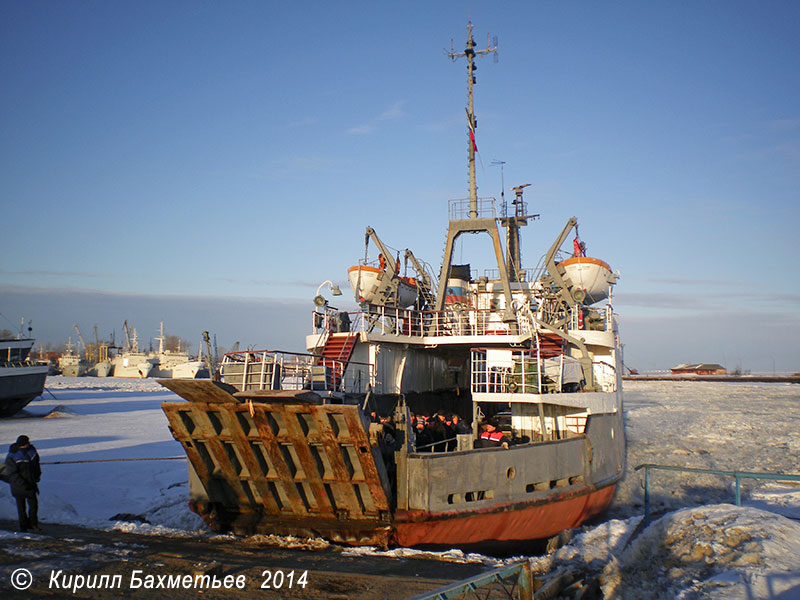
[{"xmin": 0, "ymin": 1, "xmax": 800, "ymax": 371}]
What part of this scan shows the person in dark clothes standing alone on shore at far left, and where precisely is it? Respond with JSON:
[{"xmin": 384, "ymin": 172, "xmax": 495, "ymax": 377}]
[{"xmin": 5, "ymin": 435, "xmax": 42, "ymax": 531}]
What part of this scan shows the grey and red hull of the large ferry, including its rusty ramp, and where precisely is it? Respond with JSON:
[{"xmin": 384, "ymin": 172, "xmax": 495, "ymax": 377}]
[{"xmin": 159, "ymin": 379, "xmax": 624, "ymax": 549}]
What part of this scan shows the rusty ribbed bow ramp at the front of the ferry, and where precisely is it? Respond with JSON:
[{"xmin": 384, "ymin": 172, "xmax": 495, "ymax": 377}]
[{"xmin": 159, "ymin": 380, "xmax": 392, "ymax": 546}]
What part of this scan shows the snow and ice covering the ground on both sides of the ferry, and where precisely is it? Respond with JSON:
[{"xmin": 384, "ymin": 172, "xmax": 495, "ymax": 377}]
[{"xmin": 0, "ymin": 377, "xmax": 800, "ymax": 600}]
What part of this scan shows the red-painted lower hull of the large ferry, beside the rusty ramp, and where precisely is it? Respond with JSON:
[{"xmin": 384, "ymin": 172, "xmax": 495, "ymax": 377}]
[{"xmin": 393, "ymin": 485, "xmax": 616, "ymax": 547}]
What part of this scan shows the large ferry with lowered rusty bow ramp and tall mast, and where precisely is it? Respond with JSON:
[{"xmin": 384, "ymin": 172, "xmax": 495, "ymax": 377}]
[{"xmin": 161, "ymin": 24, "xmax": 625, "ymax": 549}]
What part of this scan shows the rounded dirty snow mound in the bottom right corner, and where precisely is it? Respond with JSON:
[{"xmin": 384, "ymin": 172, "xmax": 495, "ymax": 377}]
[{"xmin": 603, "ymin": 505, "xmax": 800, "ymax": 600}]
